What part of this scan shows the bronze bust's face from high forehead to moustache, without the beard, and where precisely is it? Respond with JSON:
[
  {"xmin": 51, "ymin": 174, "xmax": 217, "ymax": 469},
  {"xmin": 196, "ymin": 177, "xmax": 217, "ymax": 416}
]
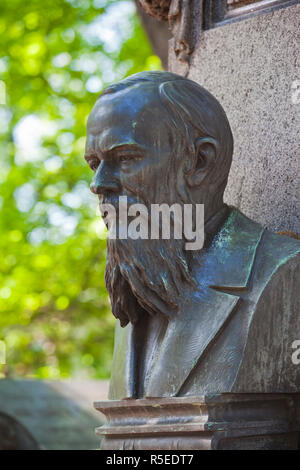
[{"xmin": 85, "ymin": 84, "xmax": 174, "ymax": 203}]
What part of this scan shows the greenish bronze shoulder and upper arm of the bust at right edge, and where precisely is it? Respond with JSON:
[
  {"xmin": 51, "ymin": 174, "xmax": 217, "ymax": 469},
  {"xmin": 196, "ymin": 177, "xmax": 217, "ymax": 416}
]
[{"xmin": 232, "ymin": 224, "xmax": 300, "ymax": 393}]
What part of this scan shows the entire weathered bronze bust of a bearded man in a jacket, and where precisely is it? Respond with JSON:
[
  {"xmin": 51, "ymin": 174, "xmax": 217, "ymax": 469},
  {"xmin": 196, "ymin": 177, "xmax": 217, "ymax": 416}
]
[{"xmin": 85, "ymin": 72, "xmax": 300, "ymax": 400}]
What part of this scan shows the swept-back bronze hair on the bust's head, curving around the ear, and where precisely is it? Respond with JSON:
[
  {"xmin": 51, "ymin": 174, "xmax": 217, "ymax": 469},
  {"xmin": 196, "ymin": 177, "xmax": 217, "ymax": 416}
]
[{"xmin": 98, "ymin": 72, "xmax": 233, "ymax": 192}]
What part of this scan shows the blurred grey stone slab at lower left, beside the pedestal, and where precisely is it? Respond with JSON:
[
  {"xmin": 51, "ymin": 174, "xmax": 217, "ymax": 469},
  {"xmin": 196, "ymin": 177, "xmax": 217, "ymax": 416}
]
[{"xmin": 0, "ymin": 379, "xmax": 108, "ymax": 450}]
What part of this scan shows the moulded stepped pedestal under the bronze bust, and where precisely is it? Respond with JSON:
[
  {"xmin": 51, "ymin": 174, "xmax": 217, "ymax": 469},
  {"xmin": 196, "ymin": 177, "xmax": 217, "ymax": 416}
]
[{"xmin": 94, "ymin": 393, "xmax": 300, "ymax": 450}]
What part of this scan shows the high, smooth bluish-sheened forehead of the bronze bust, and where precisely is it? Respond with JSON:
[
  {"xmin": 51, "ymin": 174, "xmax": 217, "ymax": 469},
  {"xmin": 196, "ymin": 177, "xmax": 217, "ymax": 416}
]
[{"xmin": 87, "ymin": 84, "xmax": 167, "ymax": 150}]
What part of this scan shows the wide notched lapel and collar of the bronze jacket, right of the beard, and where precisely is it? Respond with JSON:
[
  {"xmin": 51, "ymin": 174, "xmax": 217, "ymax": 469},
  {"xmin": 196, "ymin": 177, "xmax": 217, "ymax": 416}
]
[{"xmin": 146, "ymin": 209, "xmax": 264, "ymax": 397}]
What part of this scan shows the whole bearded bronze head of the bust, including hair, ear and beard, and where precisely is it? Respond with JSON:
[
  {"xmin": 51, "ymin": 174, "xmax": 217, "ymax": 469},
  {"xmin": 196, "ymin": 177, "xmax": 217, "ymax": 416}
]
[{"xmin": 85, "ymin": 72, "xmax": 233, "ymax": 326}]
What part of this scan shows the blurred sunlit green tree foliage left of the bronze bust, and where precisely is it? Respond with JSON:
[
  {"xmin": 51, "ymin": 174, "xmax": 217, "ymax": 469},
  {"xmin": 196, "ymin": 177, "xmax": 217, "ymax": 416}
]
[{"xmin": 0, "ymin": 0, "xmax": 161, "ymax": 379}]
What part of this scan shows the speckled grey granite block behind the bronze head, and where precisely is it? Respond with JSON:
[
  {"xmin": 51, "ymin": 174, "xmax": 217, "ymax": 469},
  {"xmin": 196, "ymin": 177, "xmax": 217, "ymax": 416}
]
[{"xmin": 169, "ymin": 4, "xmax": 300, "ymax": 234}]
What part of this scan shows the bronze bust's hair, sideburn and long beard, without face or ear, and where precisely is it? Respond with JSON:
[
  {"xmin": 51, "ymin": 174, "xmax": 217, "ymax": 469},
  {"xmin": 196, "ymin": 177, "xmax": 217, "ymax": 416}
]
[{"xmin": 99, "ymin": 72, "xmax": 233, "ymax": 327}]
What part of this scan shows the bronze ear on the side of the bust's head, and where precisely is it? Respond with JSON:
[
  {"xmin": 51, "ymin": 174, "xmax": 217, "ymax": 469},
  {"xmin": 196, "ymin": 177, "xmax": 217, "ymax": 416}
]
[{"xmin": 186, "ymin": 137, "xmax": 219, "ymax": 186}]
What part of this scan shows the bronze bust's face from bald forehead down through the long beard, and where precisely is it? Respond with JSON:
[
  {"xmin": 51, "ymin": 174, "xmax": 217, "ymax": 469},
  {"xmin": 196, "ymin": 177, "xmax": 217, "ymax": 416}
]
[{"xmin": 85, "ymin": 84, "xmax": 192, "ymax": 326}]
